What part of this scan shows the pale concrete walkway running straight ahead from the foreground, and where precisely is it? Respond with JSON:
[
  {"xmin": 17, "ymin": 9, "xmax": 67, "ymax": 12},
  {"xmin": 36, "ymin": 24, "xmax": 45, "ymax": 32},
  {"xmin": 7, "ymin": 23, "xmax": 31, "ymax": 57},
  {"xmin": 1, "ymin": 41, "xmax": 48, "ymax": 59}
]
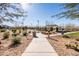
[{"xmin": 22, "ymin": 33, "xmax": 58, "ymax": 56}]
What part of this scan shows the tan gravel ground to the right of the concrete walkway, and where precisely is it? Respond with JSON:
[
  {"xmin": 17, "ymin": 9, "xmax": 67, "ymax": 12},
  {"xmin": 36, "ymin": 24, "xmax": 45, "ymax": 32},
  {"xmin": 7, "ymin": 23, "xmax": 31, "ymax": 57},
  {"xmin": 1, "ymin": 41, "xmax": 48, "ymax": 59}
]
[{"xmin": 48, "ymin": 36, "xmax": 79, "ymax": 56}]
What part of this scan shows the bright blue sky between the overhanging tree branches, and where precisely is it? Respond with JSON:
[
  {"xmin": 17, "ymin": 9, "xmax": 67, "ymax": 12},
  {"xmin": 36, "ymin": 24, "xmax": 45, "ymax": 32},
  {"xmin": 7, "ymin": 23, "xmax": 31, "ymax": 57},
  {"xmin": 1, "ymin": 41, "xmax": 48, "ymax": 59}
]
[{"xmin": 3, "ymin": 3, "xmax": 79, "ymax": 26}]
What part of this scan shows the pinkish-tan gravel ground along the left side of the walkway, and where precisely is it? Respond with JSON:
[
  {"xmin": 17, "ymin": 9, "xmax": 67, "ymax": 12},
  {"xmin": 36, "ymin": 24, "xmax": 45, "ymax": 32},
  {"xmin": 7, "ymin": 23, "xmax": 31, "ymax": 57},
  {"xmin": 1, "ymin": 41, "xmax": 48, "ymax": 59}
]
[{"xmin": 0, "ymin": 36, "xmax": 32, "ymax": 56}]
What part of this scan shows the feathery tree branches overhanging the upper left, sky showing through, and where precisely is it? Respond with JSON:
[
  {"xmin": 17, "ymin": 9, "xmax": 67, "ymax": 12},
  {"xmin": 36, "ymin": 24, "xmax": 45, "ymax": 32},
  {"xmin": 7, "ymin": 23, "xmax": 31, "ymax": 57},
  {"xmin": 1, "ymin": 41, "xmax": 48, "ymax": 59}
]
[{"xmin": 0, "ymin": 3, "xmax": 25, "ymax": 23}]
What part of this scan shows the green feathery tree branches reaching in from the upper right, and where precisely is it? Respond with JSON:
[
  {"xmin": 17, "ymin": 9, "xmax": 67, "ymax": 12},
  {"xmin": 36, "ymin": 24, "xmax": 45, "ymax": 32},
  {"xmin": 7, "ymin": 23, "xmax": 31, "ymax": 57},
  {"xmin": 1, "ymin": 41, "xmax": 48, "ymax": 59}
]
[{"xmin": 52, "ymin": 3, "xmax": 79, "ymax": 19}]
